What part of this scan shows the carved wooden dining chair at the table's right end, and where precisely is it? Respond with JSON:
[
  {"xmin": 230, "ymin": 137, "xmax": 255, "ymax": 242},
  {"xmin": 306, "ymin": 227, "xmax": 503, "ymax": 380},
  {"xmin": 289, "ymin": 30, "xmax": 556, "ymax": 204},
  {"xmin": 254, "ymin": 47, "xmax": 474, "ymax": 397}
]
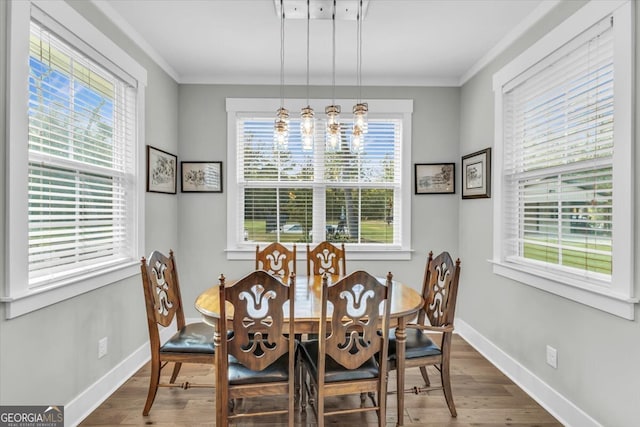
[{"xmin": 388, "ymin": 252, "xmax": 460, "ymax": 417}]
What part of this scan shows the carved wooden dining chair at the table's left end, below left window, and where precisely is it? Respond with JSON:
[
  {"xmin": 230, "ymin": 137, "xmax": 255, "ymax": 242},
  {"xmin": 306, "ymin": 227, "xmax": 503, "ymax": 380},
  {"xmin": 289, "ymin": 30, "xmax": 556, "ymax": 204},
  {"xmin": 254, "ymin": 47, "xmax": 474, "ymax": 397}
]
[{"xmin": 140, "ymin": 250, "xmax": 215, "ymax": 416}]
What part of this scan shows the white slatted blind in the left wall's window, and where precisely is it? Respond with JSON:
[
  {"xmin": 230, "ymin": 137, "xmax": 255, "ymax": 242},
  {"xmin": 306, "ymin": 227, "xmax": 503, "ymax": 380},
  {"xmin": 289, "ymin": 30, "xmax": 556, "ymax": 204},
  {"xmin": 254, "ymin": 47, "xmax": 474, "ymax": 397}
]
[{"xmin": 28, "ymin": 20, "xmax": 136, "ymax": 287}]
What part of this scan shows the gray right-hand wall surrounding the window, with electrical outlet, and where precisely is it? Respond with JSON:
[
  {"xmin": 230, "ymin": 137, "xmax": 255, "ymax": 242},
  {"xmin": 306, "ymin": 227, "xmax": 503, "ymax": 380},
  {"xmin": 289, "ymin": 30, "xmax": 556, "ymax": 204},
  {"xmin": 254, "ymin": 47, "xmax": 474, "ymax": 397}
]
[{"xmin": 457, "ymin": 1, "xmax": 640, "ymax": 427}]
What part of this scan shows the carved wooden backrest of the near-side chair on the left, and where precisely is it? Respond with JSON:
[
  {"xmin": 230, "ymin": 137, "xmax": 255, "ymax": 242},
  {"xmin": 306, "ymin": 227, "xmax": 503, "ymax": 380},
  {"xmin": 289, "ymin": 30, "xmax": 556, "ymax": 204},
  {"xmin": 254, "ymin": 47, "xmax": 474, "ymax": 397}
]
[{"xmin": 220, "ymin": 270, "xmax": 295, "ymax": 371}]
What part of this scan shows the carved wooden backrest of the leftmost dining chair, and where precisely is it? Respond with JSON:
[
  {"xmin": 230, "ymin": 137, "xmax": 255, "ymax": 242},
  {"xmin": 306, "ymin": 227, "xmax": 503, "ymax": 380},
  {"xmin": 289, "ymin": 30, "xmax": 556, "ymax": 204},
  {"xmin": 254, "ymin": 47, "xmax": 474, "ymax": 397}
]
[{"xmin": 140, "ymin": 250, "xmax": 185, "ymax": 334}]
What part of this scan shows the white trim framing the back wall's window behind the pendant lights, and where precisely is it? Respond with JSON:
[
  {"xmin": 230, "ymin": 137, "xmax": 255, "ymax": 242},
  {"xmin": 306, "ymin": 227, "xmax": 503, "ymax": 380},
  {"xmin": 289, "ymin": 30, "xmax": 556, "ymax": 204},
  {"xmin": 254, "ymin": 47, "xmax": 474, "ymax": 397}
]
[{"xmin": 226, "ymin": 98, "xmax": 413, "ymax": 260}]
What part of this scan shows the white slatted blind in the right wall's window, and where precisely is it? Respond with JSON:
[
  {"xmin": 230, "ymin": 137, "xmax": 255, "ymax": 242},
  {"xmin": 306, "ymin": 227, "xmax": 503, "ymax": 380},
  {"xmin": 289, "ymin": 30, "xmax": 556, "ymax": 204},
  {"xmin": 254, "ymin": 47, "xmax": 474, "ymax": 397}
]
[{"xmin": 502, "ymin": 17, "xmax": 614, "ymax": 281}]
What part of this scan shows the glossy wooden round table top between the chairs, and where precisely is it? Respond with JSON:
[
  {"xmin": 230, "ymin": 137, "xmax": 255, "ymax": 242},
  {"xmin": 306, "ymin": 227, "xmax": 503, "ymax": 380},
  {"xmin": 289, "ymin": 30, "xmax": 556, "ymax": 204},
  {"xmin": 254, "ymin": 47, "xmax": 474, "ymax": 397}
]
[{"xmin": 195, "ymin": 276, "xmax": 423, "ymax": 332}]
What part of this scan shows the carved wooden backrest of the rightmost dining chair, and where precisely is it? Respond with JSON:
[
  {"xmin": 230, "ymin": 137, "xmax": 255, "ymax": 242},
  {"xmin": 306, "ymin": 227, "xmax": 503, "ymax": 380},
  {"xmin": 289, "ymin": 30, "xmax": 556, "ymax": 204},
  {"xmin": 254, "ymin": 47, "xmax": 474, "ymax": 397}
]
[{"xmin": 418, "ymin": 252, "xmax": 460, "ymax": 326}]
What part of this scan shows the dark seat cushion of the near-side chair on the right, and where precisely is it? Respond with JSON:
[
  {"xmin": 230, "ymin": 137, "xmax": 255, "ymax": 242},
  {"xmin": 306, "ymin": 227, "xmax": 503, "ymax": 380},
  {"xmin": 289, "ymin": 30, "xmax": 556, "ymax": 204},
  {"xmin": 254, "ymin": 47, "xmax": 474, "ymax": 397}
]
[{"xmin": 301, "ymin": 340, "xmax": 378, "ymax": 383}]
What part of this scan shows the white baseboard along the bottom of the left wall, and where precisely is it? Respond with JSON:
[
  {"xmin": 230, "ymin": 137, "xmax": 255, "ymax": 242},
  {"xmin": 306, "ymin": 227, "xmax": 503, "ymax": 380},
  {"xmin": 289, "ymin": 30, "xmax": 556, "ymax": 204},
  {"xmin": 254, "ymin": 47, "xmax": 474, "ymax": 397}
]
[{"xmin": 64, "ymin": 319, "xmax": 182, "ymax": 427}]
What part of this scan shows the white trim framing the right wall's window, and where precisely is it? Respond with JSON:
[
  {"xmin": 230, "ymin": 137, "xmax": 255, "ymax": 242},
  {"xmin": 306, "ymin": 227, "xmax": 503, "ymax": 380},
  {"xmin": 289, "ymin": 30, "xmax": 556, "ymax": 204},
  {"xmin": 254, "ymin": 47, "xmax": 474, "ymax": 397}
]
[{"xmin": 490, "ymin": 0, "xmax": 639, "ymax": 320}]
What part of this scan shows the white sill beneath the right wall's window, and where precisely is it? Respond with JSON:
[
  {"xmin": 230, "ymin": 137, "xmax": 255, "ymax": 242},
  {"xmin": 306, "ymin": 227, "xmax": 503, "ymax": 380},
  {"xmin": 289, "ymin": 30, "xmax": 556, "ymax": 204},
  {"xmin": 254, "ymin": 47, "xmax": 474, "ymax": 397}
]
[{"xmin": 489, "ymin": 260, "xmax": 639, "ymax": 320}]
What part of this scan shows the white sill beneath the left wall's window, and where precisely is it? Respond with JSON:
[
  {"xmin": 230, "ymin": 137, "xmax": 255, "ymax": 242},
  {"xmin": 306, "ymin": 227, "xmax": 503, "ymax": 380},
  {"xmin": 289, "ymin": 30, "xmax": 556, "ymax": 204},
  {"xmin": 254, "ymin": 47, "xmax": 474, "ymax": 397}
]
[{"xmin": 0, "ymin": 261, "xmax": 140, "ymax": 319}]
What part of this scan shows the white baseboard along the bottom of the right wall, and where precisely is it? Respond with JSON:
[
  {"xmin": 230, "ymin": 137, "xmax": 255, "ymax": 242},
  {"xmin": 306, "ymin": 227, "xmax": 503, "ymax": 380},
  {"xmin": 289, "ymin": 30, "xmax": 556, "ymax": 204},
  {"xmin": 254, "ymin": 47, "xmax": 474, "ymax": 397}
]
[{"xmin": 455, "ymin": 318, "xmax": 602, "ymax": 427}]
